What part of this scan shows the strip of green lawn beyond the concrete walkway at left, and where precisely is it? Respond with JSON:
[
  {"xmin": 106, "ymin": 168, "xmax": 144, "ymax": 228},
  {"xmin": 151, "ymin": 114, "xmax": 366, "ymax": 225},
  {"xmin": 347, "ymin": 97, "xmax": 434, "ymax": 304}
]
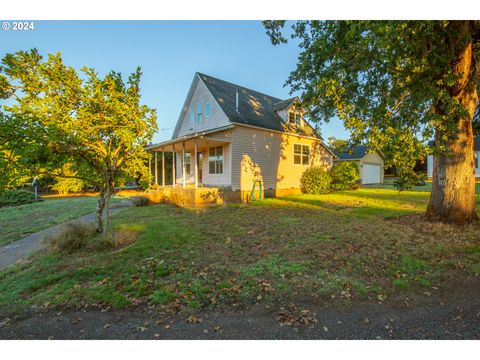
[{"xmin": 0, "ymin": 197, "xmax": 119, "ymax": 246}]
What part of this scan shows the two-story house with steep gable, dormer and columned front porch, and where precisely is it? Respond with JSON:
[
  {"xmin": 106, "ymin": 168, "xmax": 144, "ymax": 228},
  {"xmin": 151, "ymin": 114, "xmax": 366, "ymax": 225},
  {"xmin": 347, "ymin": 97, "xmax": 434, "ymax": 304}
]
[{"xmin": 147, "ymin": 73, "xmax": 335, "ymax": 203}]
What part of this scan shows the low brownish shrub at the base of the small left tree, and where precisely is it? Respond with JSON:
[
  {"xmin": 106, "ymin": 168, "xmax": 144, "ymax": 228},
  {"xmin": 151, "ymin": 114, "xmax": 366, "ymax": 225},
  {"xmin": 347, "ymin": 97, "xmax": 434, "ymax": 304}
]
[{"xmin": 50, "ymin": 222, "xmax": 95, "ymax": 253}]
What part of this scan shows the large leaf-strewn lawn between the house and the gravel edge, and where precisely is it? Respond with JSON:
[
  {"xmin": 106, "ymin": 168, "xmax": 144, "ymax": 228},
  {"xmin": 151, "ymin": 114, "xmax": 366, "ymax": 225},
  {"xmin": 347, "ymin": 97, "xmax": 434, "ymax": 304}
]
[{"xmin": 0, "ymin": 188, "xmax": 480, "ymax": 312}]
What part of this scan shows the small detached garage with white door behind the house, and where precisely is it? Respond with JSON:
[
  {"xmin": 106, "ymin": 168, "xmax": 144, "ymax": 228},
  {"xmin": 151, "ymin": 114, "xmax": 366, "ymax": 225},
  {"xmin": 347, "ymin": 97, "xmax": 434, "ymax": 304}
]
[{"xmin": 334, "ymin": 145, "xmax": 385, "ymax": 185}]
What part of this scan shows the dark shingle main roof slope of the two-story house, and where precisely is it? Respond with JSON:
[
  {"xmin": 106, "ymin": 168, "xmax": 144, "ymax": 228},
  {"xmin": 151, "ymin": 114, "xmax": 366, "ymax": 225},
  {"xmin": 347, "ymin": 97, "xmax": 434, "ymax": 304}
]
[{"xmin": 197, "ymin": 73, "xmax": 319, "ymax": 137}]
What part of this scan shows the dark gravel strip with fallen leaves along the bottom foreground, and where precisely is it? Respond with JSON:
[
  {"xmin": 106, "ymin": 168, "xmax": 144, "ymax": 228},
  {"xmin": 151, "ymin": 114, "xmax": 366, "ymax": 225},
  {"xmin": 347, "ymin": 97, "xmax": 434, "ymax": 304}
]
[{"xmin": 0, "ymin": 279, "xmax": 480, "ymax": 339}]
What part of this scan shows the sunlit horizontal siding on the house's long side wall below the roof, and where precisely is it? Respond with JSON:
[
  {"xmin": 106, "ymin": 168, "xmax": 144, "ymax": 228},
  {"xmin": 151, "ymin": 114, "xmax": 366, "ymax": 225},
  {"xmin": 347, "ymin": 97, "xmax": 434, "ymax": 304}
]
[{"xmin": 230, "ymin": 126, "xmax": 332, "ymax": 190}]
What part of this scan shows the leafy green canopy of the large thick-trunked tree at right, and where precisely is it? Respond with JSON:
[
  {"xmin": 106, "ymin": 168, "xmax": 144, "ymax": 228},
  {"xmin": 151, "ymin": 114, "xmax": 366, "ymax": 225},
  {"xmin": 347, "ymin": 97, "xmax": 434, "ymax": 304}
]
[{"xmin": 264, "ymin": 21, "xmax": 480, "ymax": 177}]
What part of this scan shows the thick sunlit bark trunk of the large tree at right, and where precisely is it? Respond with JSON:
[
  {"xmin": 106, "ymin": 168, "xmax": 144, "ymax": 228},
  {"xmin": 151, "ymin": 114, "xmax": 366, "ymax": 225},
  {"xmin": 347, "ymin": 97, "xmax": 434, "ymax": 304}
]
[{"xmin": 427, "ymin": 21, "xmax": 478, "ymax": 224}]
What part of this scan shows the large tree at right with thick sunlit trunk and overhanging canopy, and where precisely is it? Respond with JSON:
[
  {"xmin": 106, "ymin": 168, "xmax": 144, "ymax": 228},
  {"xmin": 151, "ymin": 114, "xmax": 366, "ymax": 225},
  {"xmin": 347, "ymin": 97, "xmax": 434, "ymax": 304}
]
[{"xmin": 264, "ymin": 21, "xmax": 480, "ymax": 223}]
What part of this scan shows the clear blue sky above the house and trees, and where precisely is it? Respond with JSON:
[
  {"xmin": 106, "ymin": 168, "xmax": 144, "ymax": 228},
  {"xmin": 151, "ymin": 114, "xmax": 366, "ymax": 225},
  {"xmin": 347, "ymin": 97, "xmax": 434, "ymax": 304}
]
[{"xmin": 0, "ymin": 21, "xmax": 348, "ymax": 142}]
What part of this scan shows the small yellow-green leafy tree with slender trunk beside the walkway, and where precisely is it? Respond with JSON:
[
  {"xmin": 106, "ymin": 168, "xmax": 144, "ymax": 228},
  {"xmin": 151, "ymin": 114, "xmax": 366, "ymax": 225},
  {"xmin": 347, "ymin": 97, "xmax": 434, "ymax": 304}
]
[{"xmin": 0, "ymin": 49, "xmax": 157, "ymax": 234}]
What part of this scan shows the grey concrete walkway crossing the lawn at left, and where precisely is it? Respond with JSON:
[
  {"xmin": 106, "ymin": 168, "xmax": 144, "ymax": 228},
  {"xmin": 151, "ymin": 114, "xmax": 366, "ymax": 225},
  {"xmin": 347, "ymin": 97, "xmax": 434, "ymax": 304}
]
[{"xmin": 0, "ymin": 199, "xmax": 132, "ymax": 269}]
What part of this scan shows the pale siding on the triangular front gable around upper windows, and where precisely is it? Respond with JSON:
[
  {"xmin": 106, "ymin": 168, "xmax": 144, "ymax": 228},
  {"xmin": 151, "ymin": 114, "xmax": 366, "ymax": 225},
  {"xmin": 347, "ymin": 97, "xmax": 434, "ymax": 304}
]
[{"xmin": 176, "ymin": 80, "xmax": 231, "ymax": 137}]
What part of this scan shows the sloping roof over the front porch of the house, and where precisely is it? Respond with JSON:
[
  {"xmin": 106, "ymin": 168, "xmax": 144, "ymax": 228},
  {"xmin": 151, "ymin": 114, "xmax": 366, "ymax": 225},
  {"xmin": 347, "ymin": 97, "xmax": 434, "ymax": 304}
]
[{"xmin": 146, "ymin": 124, "xmax": 235, "ymax": 151}]
